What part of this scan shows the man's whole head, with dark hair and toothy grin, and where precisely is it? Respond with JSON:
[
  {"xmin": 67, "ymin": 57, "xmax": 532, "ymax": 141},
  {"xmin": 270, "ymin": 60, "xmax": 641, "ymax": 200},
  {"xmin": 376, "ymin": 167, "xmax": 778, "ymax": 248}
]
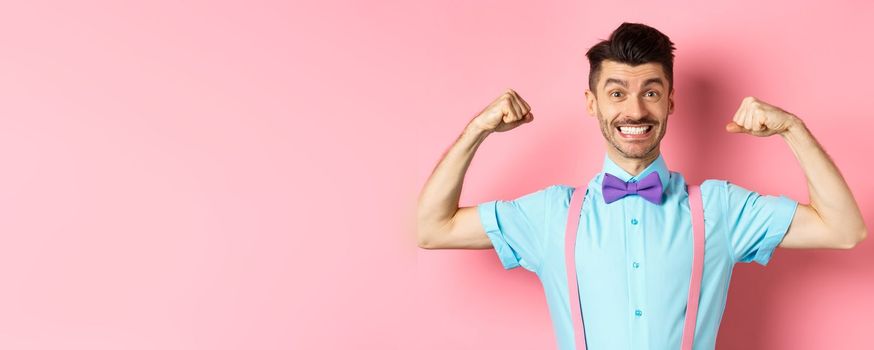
[{"xmin": 586, "ymin": 23, "xmax": 674, "ymax": 159}]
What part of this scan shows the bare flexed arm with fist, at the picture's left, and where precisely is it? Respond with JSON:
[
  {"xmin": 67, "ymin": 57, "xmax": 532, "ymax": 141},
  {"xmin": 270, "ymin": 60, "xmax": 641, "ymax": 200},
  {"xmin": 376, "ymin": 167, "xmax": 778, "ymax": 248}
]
[{"xmin": 416, "ymin": 90, "xmax": 534, "ymax": 249}]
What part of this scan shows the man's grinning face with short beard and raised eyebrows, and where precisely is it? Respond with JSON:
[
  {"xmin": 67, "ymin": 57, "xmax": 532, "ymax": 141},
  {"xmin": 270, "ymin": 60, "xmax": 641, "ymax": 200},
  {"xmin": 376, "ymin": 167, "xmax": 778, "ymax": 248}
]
[{"xmin": 586, "ymin": 60, "xmax": 674, "ymax": 159}]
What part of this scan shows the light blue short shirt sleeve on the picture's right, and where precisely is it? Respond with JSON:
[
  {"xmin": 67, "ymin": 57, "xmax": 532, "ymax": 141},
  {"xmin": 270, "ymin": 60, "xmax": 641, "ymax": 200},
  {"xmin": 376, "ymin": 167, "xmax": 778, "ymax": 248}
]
[{"xmin": 721, "ymin": 181, "xmax": 798, "ymax": 266}]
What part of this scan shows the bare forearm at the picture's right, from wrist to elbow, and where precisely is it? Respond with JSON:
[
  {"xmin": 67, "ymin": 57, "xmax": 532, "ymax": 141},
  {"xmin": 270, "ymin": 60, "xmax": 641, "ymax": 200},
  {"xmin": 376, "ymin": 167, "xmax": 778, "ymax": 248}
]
[{"xmin": 780, "ymin": 118, "xmax": 865, "ymax": 242}]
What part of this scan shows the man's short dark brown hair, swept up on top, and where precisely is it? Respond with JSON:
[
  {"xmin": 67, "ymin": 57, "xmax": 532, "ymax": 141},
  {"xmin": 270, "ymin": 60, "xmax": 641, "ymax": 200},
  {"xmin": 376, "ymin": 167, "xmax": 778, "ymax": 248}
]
[{"xmin": 586, "ymin": 22, "xmax": 675, "ymax": 92}]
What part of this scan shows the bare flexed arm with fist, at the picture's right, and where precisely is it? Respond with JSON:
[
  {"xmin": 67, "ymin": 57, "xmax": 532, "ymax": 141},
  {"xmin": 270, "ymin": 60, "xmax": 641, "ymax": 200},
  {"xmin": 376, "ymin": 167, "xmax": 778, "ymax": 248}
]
[{"xmin": 726, "ymin": 97, "xmax": 867, "ymax": 249}]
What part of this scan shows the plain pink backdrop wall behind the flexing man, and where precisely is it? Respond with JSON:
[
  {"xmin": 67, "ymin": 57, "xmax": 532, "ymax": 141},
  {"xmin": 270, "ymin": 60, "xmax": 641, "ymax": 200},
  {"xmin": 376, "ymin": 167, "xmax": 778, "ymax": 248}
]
[{"xmin": 0, "ymin": 1, "xmax": 874, "ymax": 349}]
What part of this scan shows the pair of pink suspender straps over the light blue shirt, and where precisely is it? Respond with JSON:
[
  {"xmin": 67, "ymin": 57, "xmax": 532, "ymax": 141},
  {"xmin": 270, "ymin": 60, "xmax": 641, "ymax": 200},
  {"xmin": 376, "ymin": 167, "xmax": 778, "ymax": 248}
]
[{"xmin": 564, "ymin": 186, "xmax": 704, "ymax": 350}]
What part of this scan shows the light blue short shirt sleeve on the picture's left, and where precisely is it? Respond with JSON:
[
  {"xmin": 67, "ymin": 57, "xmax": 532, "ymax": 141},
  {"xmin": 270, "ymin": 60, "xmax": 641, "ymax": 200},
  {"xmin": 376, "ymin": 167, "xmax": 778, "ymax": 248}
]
[{"xmin": 477, "ymin": 186, "xmax": 555, "ymax": 272}]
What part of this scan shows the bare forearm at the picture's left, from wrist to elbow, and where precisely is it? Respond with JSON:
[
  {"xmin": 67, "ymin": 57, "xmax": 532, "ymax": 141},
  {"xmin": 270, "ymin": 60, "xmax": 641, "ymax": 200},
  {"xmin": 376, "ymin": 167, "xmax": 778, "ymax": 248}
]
[{"xmin": 417, "ymin": 124, "xmax": 491, "ymax": 238}]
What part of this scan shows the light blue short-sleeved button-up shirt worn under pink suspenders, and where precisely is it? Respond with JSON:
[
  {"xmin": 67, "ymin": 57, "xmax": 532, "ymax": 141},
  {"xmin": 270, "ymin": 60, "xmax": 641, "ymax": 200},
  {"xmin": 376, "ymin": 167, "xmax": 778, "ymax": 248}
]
[{"xmin": 477, "ymin": 156, "xmax": 798, "ymax": 350}]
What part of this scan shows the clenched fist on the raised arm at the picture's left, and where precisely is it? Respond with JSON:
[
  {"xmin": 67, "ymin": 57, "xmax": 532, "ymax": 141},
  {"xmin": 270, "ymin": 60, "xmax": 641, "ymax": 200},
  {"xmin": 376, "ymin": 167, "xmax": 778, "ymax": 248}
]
[{"xmin": 470, "ymin": 89, "xmax": 534, "ymax": 132}]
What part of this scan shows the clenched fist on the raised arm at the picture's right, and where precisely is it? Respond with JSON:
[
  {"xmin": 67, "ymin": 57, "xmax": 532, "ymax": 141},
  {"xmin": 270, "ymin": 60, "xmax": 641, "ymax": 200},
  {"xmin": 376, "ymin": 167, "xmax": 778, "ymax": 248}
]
[{"xmin": 725, "ymin": 96, "xmax": 799, "ymax": 136}]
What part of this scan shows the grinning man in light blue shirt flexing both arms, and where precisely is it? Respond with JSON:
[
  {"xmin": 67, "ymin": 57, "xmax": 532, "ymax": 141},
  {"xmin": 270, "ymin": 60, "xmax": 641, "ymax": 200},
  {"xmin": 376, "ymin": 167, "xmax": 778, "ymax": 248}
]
[{"xmin": 418, "ymin": 23, "xmax": 867, "ymax": 350}]
